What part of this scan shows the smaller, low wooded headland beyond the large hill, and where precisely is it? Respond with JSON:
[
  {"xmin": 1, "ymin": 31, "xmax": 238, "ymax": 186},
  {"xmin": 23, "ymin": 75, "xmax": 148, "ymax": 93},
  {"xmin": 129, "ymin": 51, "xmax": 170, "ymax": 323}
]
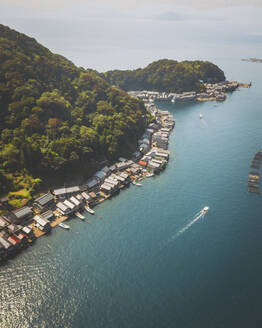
[{"xmin": 101, "ymin": 59, "xmax": 225, "ymax": 93}]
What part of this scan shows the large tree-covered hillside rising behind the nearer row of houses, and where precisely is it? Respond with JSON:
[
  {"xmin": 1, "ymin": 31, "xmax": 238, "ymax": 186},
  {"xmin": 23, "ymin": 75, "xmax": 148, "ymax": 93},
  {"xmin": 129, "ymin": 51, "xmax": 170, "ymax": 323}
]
[{"xmin": 0, "ymin": 25, "xmax": 146, "ymax": 200}]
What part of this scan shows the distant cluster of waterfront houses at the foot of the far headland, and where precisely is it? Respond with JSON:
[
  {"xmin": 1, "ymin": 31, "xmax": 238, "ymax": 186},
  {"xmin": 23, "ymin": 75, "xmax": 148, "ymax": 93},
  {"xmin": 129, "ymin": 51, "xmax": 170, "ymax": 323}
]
[{"xmin": 129, "ymin": 81, "xmax": 242, "ymax": 103}]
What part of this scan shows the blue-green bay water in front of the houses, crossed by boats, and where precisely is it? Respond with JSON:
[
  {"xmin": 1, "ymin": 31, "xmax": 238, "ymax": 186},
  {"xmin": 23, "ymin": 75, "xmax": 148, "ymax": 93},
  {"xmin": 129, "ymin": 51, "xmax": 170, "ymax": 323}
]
[{"xmin": 0, "ymin": 59, "xmax": 262, "ymax": 328}]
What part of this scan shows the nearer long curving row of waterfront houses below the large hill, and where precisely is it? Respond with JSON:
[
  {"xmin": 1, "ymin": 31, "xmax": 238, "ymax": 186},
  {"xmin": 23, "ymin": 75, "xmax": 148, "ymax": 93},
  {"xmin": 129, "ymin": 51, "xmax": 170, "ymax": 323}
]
[{"xmin": 0, "ymin": 102, "xmax": 175, "ymax": 263}]
